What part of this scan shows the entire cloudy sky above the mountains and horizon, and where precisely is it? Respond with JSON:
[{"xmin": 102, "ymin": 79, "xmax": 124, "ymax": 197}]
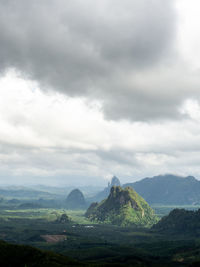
[{"xmin": 0, "ymin": 0, "xmax": 200, "ymax": 186}]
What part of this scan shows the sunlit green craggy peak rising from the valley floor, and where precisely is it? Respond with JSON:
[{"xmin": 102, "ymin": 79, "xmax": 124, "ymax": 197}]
[{"xmin": 85, "ymin": 186, "xmax": 157, "ymax": 226}]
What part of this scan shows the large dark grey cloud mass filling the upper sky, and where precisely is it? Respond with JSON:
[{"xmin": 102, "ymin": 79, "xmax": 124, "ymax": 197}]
[{"xmin": 0, "ymin": 0, "xmax": 185, "ymax": 120}]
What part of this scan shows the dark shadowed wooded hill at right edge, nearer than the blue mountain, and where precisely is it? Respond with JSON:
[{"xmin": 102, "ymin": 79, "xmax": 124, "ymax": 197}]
[{"xmin": 153, "ymin": 209, "xmax": 200, "ymax": 236}]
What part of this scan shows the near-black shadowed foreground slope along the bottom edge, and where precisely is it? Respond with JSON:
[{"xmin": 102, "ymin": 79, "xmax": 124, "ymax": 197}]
[{"xmin": 0, "ymin": 241, "xmax": 183, "ymax": 267}]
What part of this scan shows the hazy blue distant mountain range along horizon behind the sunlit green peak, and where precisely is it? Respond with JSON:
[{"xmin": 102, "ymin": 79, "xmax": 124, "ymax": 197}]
[{"xmin": 0, "ymin": 174, "xmax": 200, "ymax": 209}]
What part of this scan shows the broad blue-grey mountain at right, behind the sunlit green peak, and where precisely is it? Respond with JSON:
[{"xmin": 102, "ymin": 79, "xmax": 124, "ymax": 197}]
[{"xmin": 123, "ymin": 175, "xmax": 200, "ymax": 205}]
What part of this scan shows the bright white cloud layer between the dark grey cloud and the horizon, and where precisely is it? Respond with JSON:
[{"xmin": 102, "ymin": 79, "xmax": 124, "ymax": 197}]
[{"xmin": 0, "ymin": 73, "xmax": 200, "ymax": 185}]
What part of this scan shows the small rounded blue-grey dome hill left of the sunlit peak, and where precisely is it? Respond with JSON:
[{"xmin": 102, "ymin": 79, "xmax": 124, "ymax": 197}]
[{"xmin": 66, "ymin": 189, "xmax": 86, "ymax": 209}]
